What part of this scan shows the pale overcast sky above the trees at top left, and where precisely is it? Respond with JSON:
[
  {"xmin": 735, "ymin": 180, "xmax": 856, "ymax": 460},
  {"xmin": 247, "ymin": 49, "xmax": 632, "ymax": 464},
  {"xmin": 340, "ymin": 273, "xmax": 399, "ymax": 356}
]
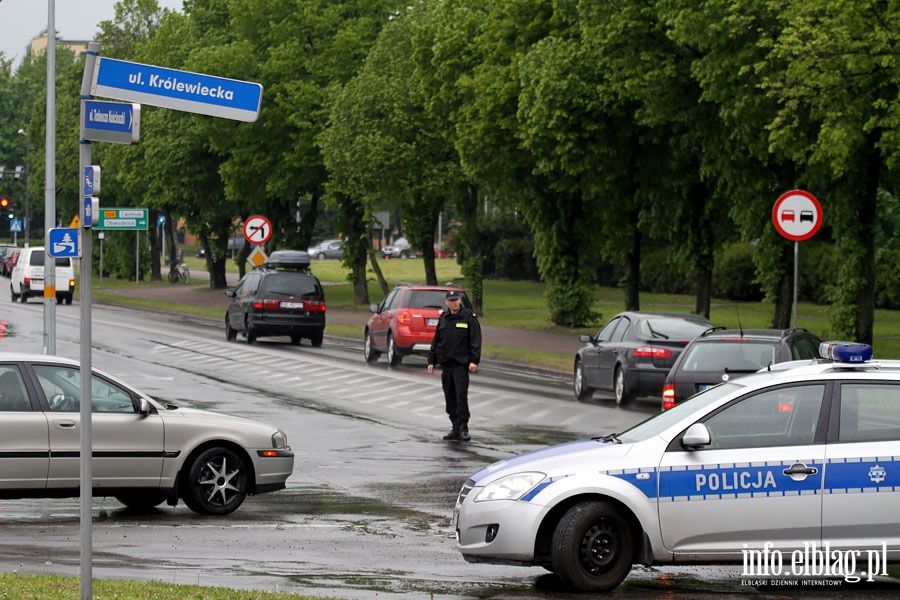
[{"xmin": 0, "ymin": 0, "xmax": 182, "ymax": 66}]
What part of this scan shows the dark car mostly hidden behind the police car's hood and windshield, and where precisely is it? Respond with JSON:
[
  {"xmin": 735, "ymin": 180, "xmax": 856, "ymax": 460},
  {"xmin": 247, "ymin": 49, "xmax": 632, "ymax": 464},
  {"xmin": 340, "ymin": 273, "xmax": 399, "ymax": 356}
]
[{"xmin": 662, "ymin": 328, "xmax": 822, "ymax": 410}]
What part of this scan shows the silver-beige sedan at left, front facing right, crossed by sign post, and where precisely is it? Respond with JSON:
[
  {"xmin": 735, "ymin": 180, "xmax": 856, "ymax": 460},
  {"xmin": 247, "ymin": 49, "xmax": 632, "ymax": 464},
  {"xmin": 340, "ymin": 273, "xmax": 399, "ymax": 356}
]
[{"xmin": 0, "ymin": 353, "xmax": 294, "ymax": 515}]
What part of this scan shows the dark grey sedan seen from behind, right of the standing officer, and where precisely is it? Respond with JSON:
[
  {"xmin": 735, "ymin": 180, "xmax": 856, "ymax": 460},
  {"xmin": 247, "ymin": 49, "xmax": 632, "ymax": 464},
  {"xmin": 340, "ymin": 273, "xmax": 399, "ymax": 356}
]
[{"xmin": 575, "ymin": 311, "xmax": 713, "ymax": 404}]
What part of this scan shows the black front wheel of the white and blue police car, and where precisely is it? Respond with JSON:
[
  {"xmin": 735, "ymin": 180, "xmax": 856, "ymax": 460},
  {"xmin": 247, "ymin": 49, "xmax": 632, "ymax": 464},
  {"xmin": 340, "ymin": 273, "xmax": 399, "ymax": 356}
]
[{"xmin": 551, "ymin": 501, "xmax": 634, "ymax": 592}]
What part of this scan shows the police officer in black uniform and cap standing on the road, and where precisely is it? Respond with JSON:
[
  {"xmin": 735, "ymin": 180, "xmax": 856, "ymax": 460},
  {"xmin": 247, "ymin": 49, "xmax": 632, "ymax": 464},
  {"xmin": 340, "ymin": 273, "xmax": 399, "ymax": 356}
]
[{"xmin": 428, "ymin": 290, "xmax": 481, "ymax": 442}]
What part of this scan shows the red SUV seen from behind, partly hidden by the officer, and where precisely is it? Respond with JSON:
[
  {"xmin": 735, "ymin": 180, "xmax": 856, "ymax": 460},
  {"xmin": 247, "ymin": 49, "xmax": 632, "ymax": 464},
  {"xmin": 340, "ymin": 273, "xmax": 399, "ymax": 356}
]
[{"xmin": 365, "ymin": 283, "xmax": 472, "ymax": 366}]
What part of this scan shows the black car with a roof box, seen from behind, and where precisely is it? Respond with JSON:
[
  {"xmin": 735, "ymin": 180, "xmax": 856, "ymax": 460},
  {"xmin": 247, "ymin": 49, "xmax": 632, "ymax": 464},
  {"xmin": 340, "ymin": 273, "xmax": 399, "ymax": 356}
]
[{"xmin": 225, "ymin": 250, "xmax": 325, "ymax": 347}]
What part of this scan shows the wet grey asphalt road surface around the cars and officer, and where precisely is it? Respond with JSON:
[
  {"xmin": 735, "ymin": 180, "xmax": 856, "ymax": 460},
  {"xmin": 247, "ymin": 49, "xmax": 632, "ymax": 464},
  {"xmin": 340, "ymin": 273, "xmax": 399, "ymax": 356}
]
[{"xmin": 0, "ymin": 299, "xmax": 900, "ymax": 600}]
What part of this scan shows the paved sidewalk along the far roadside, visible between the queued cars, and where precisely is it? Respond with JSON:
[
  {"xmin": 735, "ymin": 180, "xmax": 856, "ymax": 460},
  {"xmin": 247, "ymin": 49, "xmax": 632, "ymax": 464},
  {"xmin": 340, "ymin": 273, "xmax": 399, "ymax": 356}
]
[{"xmin": 93, "ymin": 272, "xmax": 582, "ymax": 374}]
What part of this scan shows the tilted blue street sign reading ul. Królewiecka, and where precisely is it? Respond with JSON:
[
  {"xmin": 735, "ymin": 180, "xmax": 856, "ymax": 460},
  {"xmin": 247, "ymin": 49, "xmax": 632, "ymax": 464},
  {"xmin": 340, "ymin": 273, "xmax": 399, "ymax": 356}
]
[{"xmin": 91, "ymin": 57, "xmax": 262, "ymax": 122}]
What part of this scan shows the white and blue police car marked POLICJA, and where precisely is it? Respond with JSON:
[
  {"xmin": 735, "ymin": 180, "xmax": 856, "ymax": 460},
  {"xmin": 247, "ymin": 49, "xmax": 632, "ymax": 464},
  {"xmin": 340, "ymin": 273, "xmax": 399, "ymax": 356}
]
[{"xmin": 453, "ymin": 342, "xmax": 900, "ymax": 592}]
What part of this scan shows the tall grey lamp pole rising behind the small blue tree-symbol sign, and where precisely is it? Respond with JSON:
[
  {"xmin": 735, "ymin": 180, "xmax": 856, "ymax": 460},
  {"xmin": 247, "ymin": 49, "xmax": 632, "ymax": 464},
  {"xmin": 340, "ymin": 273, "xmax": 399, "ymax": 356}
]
[{"xmin": 44, "ymin": 0, "xmax": 56, "ymax": 355}]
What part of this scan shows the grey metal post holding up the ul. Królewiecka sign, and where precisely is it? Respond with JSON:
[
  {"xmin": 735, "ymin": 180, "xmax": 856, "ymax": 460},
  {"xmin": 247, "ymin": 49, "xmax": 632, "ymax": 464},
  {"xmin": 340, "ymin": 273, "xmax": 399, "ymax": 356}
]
[{"xmin": 78, "ymin": 42, "xmax": 100, "ymax": 600}]
